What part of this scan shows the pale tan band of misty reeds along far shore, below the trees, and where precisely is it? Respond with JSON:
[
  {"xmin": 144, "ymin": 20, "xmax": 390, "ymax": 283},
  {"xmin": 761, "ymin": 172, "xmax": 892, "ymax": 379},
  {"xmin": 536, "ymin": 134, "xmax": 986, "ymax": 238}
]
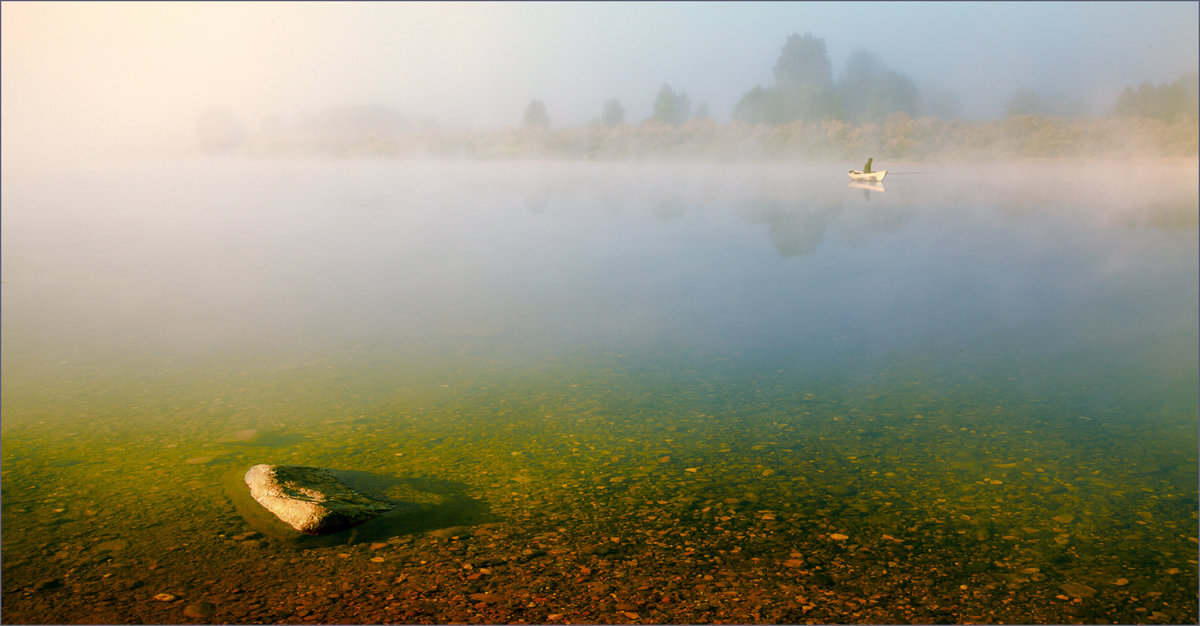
[{"xmin": 229, "ymin": 114, "xmax": 1200, "ymax": 162}]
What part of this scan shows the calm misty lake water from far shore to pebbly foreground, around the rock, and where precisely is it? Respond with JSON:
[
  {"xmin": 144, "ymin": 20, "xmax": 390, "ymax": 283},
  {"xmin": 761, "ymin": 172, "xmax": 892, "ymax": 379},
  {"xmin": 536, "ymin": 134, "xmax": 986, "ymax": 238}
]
[{"xmin": 0, "ymin": 159, "xmax": 1200, "ymax": 622}]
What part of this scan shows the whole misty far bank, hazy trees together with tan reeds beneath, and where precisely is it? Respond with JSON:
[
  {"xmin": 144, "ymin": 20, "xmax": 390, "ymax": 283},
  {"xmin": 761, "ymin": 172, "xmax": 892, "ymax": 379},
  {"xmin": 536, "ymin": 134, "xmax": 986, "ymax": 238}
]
[{"xmin": 196, "ymin": 34, "xmax": 1200, "ymax": 159}]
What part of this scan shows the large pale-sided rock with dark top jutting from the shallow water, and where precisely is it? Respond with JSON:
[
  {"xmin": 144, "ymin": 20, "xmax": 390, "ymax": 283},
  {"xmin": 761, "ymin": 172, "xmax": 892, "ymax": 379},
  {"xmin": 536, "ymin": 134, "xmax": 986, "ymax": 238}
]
[{"xmin": 246, "ymin": 464, "xmax": 391, "ymax": 535}]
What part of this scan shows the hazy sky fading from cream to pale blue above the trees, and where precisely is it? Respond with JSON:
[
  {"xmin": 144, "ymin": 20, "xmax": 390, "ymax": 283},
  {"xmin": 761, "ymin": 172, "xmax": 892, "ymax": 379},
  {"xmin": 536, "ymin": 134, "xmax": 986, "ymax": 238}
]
[{"xmin": 0, "ymin": 1, "xmax": 1200, "ymax": 151}]
